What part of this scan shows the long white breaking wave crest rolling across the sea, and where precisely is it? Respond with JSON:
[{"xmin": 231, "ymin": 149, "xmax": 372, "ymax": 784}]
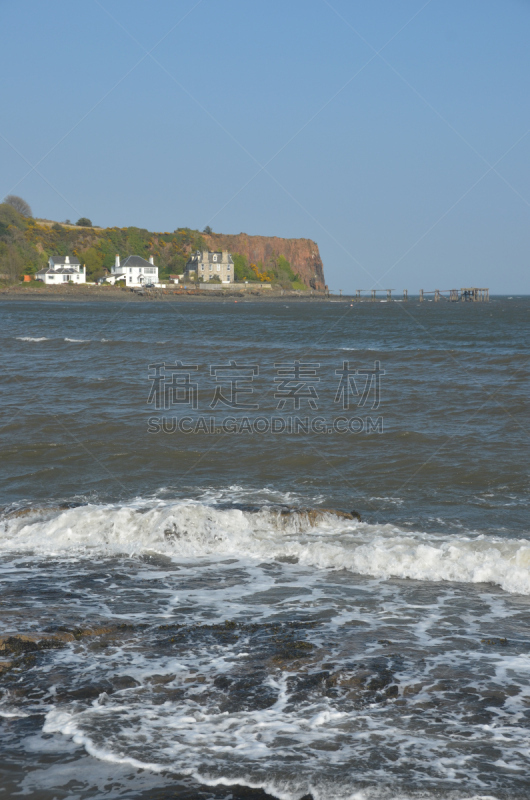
[{"xmin": 0, "ymin": 502, "xmax": 530, "ymax": 594}]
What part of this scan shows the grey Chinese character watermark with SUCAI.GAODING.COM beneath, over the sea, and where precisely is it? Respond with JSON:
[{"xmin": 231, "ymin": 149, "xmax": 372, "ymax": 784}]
[{"xmin": 147, "ymin": 359, "xmax": 386, "ymax": 435}]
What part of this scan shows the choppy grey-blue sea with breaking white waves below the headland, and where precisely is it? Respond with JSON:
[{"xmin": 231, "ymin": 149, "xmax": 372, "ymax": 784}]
[{"xmin": 0, "ymin": 298, "xmax": 530, "ymax": 800}]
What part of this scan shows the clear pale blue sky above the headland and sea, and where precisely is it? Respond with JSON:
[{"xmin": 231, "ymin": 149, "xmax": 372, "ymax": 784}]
[{"xmin": 0, "ymin": 0, "xmax": 530, "ymax": 293}]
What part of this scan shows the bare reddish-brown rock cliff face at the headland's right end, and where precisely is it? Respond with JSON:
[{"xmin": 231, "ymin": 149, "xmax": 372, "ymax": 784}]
[{"xmin": 202, "ymin": 233, "xmax": 326, "ymax": 291}]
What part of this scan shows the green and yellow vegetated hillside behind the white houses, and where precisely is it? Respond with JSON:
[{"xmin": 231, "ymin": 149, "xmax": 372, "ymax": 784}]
[{"xmin": 0, "ymin": 208, "xmax": 305, "ymax": 288}]
